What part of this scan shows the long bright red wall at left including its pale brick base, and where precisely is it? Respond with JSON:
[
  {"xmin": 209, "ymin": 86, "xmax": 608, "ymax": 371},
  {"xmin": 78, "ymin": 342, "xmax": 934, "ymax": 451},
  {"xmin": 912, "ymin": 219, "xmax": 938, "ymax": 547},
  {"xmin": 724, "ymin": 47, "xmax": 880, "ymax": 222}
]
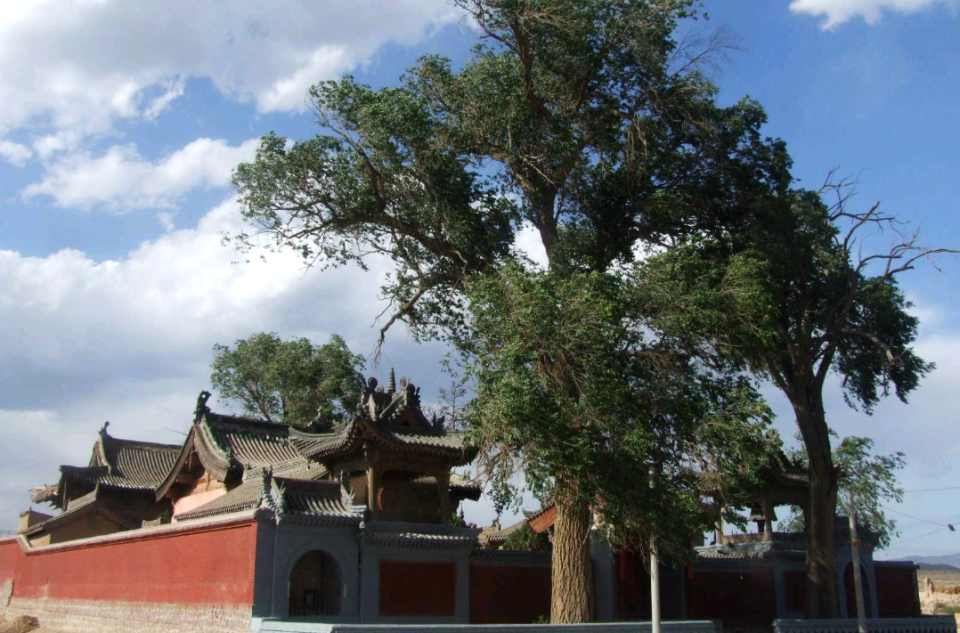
[{"xmin": 0, "ymin": 515, "xmax": 257, "ymax": 633}]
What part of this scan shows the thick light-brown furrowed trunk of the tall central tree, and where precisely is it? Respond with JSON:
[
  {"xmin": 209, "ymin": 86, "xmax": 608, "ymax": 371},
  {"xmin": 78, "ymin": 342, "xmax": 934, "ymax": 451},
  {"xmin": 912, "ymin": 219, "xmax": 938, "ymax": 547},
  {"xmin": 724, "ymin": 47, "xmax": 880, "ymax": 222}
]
[{"xmin": 550, "ymin": 491, "xmax": 593, "ymax": 624}]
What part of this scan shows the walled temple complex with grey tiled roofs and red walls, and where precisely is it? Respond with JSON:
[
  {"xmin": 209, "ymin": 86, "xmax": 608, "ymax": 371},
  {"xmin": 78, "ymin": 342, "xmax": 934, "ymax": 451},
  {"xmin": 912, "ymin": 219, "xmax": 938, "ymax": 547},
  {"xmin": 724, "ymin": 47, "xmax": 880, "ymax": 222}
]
[{"xmin": 0, "ymin": 370, "xmax": 919, "ymax": 633}]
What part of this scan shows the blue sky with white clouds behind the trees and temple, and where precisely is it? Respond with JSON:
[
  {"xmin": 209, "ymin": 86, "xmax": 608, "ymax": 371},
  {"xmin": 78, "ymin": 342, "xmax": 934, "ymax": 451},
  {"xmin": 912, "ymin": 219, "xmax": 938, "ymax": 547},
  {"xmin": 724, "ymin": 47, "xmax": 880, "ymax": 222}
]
[{"xmin": 0, "ymin": 0, "xmax": 960, "ymax": 557}]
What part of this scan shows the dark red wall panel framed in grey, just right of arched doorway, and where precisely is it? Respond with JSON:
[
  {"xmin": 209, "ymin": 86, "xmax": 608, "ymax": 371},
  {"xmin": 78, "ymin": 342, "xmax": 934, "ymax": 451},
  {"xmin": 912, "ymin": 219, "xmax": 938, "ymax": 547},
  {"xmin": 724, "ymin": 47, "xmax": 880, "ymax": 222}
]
[{"xmin": 380, "ymin": 560, "xmax": 457, "ymax": 616}]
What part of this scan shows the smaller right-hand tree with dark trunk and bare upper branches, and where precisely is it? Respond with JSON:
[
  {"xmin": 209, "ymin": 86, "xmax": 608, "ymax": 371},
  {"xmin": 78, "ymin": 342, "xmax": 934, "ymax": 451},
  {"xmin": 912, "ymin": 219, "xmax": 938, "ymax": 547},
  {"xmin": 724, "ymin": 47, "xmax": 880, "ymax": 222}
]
[{"xmin": 636, "ymin": 177, "xmax": 945, "ymax": 617}]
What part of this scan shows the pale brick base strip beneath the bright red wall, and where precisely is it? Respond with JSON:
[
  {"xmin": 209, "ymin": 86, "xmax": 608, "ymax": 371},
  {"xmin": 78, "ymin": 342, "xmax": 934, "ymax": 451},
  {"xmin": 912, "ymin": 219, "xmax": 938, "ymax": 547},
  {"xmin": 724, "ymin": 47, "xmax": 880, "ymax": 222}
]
[{"xmin": 0, "ymin": 598, "xmax": 251, "ymax": 633}]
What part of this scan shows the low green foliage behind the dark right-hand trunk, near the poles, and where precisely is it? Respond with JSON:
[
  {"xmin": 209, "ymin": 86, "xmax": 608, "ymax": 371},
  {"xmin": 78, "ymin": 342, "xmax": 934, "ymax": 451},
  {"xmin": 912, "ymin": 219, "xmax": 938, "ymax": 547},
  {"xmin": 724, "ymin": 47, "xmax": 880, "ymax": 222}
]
[{"xmin": 781, "ymin": 437, "xmax": 905, "ymax": 549}]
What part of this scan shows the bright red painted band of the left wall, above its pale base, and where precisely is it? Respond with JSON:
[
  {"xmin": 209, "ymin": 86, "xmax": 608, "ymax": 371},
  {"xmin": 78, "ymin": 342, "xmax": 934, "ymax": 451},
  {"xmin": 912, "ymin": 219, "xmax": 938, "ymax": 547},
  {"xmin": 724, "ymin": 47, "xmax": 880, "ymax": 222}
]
[{"xmin": 0, "ymin": 521, "xmax": 257, "ymax": 605}]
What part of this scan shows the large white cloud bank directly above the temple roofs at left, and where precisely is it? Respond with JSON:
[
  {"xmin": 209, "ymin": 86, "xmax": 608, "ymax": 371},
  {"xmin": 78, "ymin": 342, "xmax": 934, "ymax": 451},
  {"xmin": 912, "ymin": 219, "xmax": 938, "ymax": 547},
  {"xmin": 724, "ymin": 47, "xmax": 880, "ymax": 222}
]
[{"xmin": 0, "ymin": 194, "xmax": 478, "ymax": 528}]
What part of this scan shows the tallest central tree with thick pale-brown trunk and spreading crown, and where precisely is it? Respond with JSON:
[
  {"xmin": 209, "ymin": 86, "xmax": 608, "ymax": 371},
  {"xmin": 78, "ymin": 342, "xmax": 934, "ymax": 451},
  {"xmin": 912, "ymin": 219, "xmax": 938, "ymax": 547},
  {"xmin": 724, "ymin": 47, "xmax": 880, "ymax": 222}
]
[{"xmin": 234, "ymin": 0, "xmax": 868, "ymax": 623}]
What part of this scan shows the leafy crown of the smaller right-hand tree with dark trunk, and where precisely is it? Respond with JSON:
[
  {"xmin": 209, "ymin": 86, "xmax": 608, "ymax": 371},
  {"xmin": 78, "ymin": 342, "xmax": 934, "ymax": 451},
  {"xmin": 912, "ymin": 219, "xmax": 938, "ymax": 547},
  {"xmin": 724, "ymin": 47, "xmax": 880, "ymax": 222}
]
[{"xmin": 637, "ymin": 191, "xmax": 933, "ymax": 412}]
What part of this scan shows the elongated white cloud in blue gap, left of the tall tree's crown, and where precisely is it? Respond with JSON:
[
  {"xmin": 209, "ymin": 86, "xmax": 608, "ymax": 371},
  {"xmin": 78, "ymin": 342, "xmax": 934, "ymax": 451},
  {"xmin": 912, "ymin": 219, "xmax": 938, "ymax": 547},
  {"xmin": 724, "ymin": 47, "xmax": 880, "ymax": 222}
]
[{"xmin": 21, "ymin": 138, "xmax": 259, "ymax": 210}]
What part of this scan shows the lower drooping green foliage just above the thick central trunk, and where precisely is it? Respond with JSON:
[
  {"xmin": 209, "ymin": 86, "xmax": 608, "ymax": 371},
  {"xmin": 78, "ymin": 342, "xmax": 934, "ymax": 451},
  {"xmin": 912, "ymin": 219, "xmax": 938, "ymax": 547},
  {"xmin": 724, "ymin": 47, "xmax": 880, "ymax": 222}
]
[{"xmin": 467, "ymin": 265, "xmax": 769, "ymax": 559}]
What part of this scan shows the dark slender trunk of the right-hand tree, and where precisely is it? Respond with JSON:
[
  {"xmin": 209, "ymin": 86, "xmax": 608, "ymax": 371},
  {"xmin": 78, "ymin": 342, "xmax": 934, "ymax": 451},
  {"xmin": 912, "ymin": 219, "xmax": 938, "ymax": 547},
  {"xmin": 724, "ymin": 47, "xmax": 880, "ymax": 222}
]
[{"xmin": 793, "ymin": 385, "xmax": 839, "ymax": 619}]
